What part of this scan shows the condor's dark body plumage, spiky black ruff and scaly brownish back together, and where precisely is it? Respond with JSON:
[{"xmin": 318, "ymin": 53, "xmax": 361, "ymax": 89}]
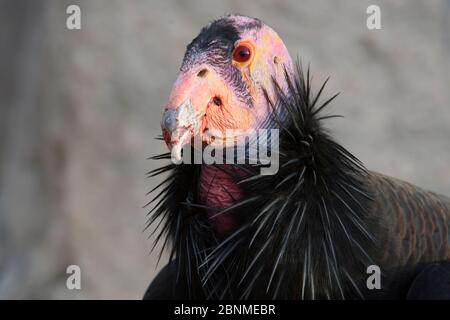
[{"xmin": 145, "ymin": 63, "xmax": 450, "ymax": 299}]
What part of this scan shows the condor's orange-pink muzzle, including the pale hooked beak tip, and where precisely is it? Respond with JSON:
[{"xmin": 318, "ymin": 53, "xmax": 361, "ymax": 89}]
[{"xmin": 161, "ymin": 65, "xmax": 251, "ymax": 163}]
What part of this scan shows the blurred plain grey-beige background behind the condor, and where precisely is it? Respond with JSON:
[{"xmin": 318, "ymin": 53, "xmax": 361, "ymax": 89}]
[{"xmin": 0, "ymin": 0, "xmax": 450, "ymax": 299}]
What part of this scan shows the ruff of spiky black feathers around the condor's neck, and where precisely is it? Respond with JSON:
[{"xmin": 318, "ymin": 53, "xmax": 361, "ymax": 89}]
[{"xmin": 149, "ymin": 64, "xmax": 378, "ymax": 299}]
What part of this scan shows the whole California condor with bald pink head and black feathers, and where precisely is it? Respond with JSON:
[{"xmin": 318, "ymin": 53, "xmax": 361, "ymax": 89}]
[{"xmin": 144, "ymin": 15, "xmax": 450, "ymax": 299}]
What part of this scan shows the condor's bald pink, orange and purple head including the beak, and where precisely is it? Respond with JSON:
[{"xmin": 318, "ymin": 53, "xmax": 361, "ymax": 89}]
[{"xmin": 162, "ymin": 16, "xmax": 293, "ymax": 158}]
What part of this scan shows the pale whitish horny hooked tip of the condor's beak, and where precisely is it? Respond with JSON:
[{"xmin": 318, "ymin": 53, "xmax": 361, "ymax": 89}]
[{"xmin": 161, "ymin": 98, "xmax": 199, "ymax": 162}]
